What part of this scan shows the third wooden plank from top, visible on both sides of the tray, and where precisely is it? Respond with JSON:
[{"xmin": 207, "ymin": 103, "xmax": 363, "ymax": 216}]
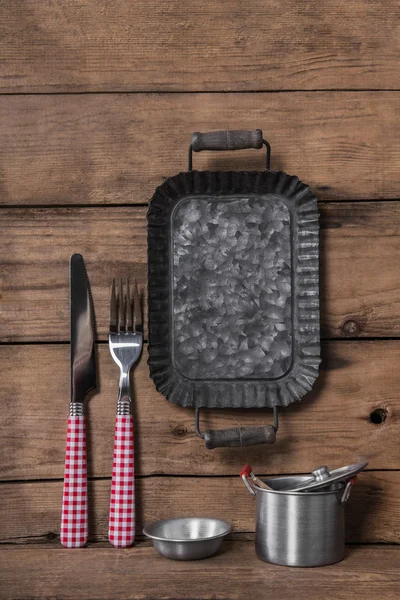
[{"xmin": 0, "ymin": 202, "xmax": 400, "ymax": 342}]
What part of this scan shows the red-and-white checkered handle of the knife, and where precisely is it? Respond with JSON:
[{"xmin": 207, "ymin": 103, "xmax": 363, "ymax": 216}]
[{"xmin": 60, "ymin": 416, "xmax": 88, "ymax": 548}]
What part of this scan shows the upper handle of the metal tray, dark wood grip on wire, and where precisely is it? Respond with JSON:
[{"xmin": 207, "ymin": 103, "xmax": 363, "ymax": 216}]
[{"xmin": 188, "ymin": 129, "xmax": 271, "ymax": 171}]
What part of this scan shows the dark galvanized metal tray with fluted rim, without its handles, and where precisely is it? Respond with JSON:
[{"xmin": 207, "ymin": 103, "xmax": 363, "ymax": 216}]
[{"xmin": 148, "ymin": 171, "xmax": 320, "ymax": 408}]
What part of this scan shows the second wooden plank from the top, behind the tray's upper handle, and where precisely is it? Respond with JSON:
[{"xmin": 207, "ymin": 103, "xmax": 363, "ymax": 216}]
[{"xmin": 0, "ymin": 92, "xmax": 400, "ymax": 205}]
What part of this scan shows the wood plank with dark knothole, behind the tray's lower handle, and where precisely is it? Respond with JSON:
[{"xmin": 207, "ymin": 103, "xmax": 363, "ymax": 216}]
[{"xmin": 0, "ymin": 341, "xmax": 400, "ymax": 480}]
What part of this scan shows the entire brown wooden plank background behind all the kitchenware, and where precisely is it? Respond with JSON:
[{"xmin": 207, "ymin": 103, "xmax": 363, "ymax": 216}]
[{"xmin": 0, "ymin": 0, "xmax": 400, "ymax": 600}]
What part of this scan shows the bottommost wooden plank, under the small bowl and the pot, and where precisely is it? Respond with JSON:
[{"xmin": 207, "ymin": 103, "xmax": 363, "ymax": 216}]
[{"xmin": 0, "ymin": 542, "xmax": 400, "ymax": 600}]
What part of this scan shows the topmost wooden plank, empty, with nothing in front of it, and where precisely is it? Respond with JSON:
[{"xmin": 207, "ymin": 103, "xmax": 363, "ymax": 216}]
[{"xmin": 0, "ymin": 0, "xmax": 400, "ymax": 93}]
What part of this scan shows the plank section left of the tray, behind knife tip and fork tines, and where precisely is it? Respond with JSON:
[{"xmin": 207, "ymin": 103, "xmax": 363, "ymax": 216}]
[{"xmin": 0, "ymin": 207, "xmax": 147, "ymax": 341}]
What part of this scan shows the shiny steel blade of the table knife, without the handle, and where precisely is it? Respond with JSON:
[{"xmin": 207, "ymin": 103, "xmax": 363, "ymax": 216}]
[{"xmin": 70, "ymin": 254, "xmax": 96, "ymax": 403}]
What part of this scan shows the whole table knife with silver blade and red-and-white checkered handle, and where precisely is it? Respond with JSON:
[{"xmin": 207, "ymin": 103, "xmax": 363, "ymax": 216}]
[{"xmin": 60, "ymin": 254, "xmax": 96, "ymax": 548}]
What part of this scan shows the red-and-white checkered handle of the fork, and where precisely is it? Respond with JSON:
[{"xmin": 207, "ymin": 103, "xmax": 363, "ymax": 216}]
[{"xmin": 108, "ymin": 415, "xmax": 135, "ymax": 548}]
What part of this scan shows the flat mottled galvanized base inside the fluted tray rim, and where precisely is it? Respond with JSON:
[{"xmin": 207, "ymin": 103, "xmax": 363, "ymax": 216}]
[{"xmin": 172, "ymin": 194, "xmax": 293, "ymax": 380}]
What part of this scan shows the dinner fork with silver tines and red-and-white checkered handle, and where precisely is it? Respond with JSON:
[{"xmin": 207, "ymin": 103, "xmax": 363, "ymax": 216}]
[{"xmin": 108, "ymin": 278, "xmax": 143, "ymax": 548}]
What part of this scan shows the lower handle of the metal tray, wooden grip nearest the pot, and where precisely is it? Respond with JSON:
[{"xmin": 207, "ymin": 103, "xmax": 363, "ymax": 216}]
[{"xmin": 195, "ymin": 407, "xmax": 278, "ymax": 450}]
